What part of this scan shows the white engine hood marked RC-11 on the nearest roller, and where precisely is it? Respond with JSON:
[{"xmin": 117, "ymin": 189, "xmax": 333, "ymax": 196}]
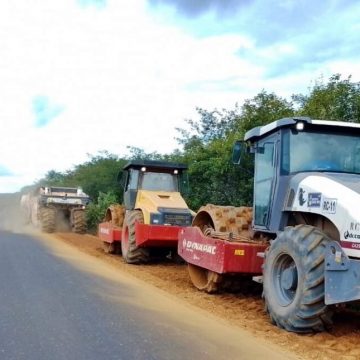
[{"xmin": 284, "ymin": 173, "xmax": 360, "ymax": 257}]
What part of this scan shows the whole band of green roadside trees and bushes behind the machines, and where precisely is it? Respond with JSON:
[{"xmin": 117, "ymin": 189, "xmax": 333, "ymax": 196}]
[{"xmin": 23, "ymin": 74, "xmax": 360, "ymax": 228}]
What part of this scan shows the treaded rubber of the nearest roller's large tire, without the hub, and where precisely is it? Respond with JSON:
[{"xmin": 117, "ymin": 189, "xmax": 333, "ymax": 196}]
[{"xmin": 263, "ymin": 225, "xmax": 332, "ymax": 333}]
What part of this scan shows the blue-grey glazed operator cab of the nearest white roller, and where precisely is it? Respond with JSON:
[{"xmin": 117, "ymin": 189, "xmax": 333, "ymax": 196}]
[{"xmin": 233, "ymin": 117, "xmax": 360, "ymax": 233}]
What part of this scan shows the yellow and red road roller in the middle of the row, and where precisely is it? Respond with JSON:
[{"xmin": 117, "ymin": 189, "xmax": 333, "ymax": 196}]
[{"xmin": 98, "ymin": 160, "xmax": 193, "ymax": 264}]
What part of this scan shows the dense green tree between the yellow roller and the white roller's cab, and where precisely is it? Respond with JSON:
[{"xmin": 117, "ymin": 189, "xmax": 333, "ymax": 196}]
[{"xmin": 178, "ymin": 91, "xmax": 294, "ymax": 210}]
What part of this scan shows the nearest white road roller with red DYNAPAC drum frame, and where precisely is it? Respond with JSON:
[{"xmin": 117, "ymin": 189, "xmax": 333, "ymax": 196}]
[{"xmin": 178, "ymin": 117, "xmax": 360, "ymax": 332}]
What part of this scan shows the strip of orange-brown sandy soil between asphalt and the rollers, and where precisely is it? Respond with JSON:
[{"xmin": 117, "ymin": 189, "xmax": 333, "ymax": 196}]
[{"xmin": 44, "ymin": 233, "xmax": 360, "ymax": 360}]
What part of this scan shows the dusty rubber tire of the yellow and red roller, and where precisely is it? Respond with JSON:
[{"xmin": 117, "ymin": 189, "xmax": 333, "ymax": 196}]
[{"xmin": 121, "ymin": 210, "xmax": 150, "ymax": 264}]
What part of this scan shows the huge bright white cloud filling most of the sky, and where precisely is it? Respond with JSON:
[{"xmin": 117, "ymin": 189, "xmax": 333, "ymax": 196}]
[{"xmin": 0, "ymin": 0, "xmax": 360, "ymax": 192}]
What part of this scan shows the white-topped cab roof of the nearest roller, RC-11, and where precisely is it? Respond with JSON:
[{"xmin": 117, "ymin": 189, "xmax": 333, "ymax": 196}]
[{"xmin": 244, "ymin": 117, "xmax": 360, "ymax": 141}]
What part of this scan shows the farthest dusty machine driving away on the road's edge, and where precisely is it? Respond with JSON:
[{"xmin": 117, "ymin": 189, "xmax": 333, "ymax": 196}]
[{"xmin": 20, "ymin": 186, "xmax": 90, "ymax": 234}]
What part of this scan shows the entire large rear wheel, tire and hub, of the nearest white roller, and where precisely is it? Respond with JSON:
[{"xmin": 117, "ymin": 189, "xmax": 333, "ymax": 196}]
[{"xmin": 263, "ymin": 225, "xmax": 332, "ymax": 333}]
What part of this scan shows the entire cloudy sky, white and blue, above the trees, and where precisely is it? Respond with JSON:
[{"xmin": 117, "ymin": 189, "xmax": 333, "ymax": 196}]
[{"xmin": 0, "ymin": 0, "xmax": 360, "ymax": 192}]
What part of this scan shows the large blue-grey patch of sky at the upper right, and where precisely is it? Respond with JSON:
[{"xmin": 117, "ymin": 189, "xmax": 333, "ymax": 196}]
[{"xmin": 149, "ymin": 0, "xmax": 360, "ymax": 79}]
